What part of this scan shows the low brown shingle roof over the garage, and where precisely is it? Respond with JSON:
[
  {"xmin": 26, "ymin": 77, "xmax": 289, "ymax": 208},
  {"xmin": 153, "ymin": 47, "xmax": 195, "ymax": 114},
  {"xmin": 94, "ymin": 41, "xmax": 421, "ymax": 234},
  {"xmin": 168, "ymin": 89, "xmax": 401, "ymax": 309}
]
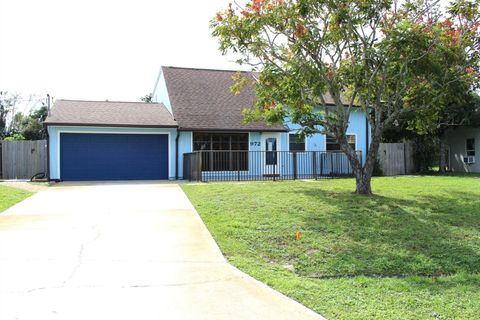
[{"xmin": 45, "ymin": 100, "xmax": 177, "ymax": 127}]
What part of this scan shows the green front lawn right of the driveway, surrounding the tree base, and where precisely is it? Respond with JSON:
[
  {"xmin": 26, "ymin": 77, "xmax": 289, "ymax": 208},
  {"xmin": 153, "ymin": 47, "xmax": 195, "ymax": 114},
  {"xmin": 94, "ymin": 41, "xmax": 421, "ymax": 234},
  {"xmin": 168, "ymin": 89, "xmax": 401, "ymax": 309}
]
[{"xmin": 183, "ymin": 176, "xmax": 480, "ymax": 319}]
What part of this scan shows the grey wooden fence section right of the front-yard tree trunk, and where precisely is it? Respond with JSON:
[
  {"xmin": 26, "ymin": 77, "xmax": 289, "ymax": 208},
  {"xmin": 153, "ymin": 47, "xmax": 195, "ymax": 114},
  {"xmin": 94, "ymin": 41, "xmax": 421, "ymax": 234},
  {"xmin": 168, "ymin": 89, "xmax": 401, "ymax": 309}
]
[{"xmin": 378, "ymin": 143, "xmax": 415, "ymax": 176}]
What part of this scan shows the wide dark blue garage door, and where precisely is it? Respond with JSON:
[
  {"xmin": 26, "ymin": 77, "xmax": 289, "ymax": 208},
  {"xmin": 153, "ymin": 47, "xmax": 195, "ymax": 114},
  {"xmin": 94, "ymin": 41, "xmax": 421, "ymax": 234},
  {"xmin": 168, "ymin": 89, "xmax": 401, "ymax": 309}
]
[{"xmin": 60, "ymin": 133, "xmax": 168, "ymax": 181}]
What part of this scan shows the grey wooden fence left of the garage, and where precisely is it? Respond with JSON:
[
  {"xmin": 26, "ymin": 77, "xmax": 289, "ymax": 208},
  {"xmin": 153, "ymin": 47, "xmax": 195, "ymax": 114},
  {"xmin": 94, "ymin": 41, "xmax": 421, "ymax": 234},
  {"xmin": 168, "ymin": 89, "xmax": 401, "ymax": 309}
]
[{"xmin": 0, "ymin": 140, "xmax": 47, "ymax": 179}]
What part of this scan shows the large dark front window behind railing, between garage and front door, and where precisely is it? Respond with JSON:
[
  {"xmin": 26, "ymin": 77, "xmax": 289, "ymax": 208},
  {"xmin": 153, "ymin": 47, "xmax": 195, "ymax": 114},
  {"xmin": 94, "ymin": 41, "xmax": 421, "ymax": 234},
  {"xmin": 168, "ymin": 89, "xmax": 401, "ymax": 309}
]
[{"xmin": 193, "ymin": 132, "xmax": 248, "ymax": 171}]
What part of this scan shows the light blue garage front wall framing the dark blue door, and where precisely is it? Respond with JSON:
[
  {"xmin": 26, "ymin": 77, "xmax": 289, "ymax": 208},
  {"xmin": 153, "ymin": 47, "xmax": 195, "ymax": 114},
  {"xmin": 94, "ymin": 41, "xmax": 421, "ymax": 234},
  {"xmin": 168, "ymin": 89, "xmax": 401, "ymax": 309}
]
[{"xmin": 48, "ymin": 126, "xmax": 177, "ymax": 179}]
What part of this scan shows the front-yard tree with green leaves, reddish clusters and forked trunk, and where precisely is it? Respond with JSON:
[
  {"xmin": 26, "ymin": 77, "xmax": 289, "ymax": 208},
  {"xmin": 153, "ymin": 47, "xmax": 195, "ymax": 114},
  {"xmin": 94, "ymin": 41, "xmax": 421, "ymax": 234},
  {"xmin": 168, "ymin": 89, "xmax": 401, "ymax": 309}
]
[{"xmin": 211, "ymin": 0, "xmax": 480, "ymax": 194}]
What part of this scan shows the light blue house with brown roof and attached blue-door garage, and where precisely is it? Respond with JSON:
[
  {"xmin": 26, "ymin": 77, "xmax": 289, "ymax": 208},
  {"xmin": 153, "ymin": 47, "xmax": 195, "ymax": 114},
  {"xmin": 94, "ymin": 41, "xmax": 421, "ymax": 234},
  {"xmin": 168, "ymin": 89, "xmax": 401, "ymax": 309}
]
[{"xmin": 45, "ymin": 67, "xmax": 368, "ymax": 180}]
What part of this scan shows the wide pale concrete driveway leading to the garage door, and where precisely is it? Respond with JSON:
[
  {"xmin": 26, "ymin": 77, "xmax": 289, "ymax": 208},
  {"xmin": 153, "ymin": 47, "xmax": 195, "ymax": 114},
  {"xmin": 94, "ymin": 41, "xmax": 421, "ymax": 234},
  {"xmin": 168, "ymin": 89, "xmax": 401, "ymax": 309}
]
[{"xmin": 0, "ymin": 182, "xmax": 322, "ymax": 320}]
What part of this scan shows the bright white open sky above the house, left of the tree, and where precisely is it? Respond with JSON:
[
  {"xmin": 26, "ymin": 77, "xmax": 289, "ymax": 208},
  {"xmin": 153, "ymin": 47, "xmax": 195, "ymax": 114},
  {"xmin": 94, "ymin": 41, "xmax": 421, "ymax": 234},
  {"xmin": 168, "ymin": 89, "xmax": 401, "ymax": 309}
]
[{"xmin": 0, "ymin": 0, "xmax": 238, "ymax": 100}]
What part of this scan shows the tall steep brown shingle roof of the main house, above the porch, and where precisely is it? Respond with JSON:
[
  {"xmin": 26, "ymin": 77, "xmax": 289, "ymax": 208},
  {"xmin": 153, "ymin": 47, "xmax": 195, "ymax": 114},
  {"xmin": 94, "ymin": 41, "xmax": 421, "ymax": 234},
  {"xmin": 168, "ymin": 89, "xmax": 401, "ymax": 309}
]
[{"xmin": 162, "ymin": 67, "xmax": 286, "ymax": 131}]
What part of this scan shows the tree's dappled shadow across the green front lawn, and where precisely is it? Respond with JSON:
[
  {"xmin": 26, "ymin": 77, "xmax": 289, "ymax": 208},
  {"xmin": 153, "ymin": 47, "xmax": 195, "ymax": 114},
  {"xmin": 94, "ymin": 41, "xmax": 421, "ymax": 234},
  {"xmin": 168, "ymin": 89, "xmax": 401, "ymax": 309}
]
[{"xmin": 284, "ymin": 188, "xmax": 480, "ymax": 277}]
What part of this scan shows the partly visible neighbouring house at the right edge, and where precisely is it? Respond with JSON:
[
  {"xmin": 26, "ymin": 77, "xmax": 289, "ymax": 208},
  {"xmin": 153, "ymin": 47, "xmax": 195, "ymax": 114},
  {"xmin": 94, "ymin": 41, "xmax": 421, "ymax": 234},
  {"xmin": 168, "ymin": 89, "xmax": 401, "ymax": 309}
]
[{"xmin": 445, "ymin": 126, "xmax": 480, "ymax": 172}]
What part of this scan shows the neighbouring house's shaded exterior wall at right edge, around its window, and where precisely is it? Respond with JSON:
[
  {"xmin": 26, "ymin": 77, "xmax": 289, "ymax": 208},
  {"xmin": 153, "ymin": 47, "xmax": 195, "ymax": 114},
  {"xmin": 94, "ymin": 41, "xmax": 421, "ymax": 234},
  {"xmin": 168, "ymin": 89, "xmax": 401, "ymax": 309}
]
[{"xmin": 446, "ymin": 127, "xmax": 480, "ymax": 172}]
